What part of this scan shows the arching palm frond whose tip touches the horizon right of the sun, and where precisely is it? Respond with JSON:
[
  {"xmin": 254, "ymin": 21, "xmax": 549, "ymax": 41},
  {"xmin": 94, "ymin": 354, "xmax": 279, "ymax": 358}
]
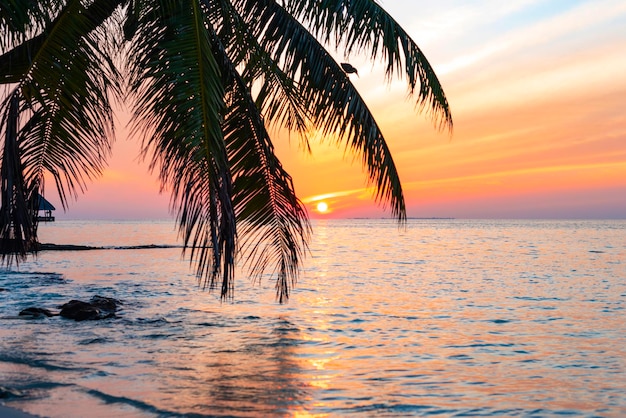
[{"xmin": 234, "ymin": 0, "xmax": 406, "ymax": 219}]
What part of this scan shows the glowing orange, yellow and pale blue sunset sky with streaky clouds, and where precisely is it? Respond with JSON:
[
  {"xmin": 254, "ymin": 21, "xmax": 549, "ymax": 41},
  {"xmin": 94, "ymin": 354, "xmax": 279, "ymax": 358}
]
[{"xmin": 49, "ymin": 0, "xmax": 626, "ymax": 219}]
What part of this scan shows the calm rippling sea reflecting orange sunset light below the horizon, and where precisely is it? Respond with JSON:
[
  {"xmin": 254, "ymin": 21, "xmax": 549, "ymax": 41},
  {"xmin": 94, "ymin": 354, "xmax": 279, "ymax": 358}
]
[{"xmin": 0, "ymin": 220, "xmax": 626, "ymax": 418}]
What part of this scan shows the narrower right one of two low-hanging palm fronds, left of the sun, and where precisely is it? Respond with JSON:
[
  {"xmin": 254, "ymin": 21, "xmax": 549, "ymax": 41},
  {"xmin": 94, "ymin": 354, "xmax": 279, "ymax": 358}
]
[{"xmin": 206, "ymin": 18, "xmax": 310, "ymax": 303}]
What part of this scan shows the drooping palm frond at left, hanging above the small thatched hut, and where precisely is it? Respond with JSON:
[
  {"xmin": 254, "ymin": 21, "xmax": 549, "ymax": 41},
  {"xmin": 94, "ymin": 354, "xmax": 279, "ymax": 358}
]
[{"xmin": 7, "ymin": 1, "xmax": 119, "ymax": 207}]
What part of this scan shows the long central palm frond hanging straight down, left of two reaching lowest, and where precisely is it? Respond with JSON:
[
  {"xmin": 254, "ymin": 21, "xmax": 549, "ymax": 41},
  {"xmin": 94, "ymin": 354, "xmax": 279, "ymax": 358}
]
[{"xmin": 129, "ymin": 0, "xmax": 236, "ymax": 297}]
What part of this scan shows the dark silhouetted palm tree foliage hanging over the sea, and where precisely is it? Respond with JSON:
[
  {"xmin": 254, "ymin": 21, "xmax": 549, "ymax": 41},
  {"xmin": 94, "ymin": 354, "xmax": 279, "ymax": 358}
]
[{"xmin": 0, "ymin": 0, "xmax": 452, "ymax": 301}]
